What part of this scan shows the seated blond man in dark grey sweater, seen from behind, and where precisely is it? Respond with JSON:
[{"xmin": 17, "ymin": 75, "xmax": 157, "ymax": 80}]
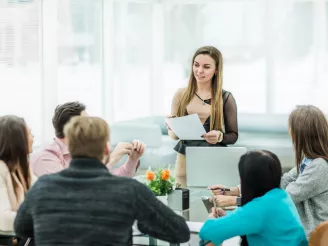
[{"xmin": 14, "ymin": 116, "xmax": 190, "ymax": 245}]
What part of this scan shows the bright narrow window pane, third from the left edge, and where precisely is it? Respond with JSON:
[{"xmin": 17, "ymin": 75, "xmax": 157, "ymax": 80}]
[{"xmin": 110, "ymin": 1, "xmax": 153, "ymax": 120}]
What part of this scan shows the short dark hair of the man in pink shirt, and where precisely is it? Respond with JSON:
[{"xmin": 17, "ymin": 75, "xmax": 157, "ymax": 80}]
[{"xmin": 52, "ymin": 102, "xmax": 86, "ymax": 138}]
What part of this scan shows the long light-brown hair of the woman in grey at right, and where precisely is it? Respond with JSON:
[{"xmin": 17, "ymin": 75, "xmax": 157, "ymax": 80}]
[{"xmin": 288, "ymin": 105, "xmax": 328, "ymax": 171}]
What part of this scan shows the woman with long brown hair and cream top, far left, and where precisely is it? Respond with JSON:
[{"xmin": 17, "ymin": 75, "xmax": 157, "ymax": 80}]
[{"xmin": 0, "ymin": 116, "xmax": 35, "ymax": 231}]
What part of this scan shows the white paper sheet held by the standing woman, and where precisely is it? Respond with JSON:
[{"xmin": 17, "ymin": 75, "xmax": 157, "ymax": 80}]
[{"xmin": 166, "ymin": 114, "xmax": 206, "ymax": 140}]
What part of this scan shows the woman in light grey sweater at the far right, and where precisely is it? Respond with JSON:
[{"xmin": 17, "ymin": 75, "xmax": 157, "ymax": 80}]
[{"xmin": 281, "ymin": 105, "xmax": 328, "ymax": 236}]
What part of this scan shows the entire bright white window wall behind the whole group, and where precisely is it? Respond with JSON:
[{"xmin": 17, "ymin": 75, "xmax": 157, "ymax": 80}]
[{"xmin": 0, "ymin": 0, "xmax": 328, "ymax": 148}]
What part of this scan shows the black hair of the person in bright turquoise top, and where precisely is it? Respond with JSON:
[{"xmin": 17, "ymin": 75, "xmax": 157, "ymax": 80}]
[{"xmin": 239, "ymin": 150, "xmax": 282, "ymax": 246}]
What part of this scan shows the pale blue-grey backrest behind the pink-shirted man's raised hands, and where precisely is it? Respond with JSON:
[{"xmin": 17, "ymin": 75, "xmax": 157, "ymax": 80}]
[{"xmin": 110, "ymin": 123, "xmax": 162, "ymax": 148}]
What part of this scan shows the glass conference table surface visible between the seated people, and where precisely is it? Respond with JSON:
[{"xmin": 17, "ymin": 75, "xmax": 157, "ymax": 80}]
[{"xmin": 0, "ymin": 188, "xmax": 240, "ymax": 246}]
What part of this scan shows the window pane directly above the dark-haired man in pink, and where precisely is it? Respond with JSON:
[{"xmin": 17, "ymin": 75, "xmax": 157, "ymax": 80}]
[{"xmin": 57, "ymin": 0, "xmax": 103, "ymax": 116}]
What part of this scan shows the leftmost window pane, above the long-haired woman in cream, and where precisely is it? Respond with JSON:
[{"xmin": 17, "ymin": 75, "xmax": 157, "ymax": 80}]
[{"xmin": 0, "ymin": 0, "xmax": 43, "ymax": 145}]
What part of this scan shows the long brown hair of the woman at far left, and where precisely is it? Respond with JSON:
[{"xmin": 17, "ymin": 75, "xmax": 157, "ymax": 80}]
[{"xmin": 0, "ymin": 115, "xmax": 31, "ymax": 195}]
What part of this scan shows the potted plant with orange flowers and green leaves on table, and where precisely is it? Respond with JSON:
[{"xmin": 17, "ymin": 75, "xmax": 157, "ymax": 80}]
[{"xmin": 146, "ymin": 167, "xmax": 175, "ymax": 205}]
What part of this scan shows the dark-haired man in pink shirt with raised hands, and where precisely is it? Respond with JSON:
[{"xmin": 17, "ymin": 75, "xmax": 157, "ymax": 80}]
[{"xmin": 30, "ymin": 102, "xmax": 145, "ymax": 177}]
